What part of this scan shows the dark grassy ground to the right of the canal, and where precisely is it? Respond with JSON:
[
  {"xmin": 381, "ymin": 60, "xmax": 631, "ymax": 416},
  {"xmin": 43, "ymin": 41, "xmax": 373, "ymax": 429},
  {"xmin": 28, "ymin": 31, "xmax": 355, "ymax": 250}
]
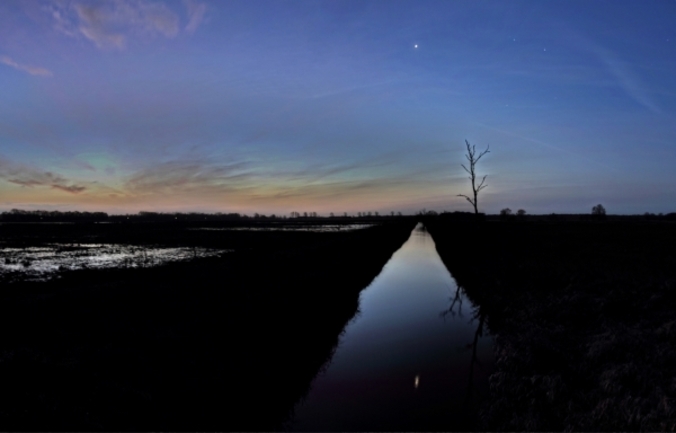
[{"xmin": 426, "ymin": 218, "xmax": 676, "ymax": 431}]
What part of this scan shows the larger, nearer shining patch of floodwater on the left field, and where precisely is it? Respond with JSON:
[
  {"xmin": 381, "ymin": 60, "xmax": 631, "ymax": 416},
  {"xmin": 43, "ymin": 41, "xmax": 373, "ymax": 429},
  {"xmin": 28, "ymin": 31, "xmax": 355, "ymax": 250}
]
[{"xmin": 0, "ymin": 243, "xmax": 229, "ymax": 282}]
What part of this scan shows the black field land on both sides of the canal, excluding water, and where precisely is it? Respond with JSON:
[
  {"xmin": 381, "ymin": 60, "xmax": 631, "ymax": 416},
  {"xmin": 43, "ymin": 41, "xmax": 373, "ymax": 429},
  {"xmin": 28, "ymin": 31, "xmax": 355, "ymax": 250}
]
[{"xmin": 0, "ymin": 217, "xmax": 676, "ymax": 431}]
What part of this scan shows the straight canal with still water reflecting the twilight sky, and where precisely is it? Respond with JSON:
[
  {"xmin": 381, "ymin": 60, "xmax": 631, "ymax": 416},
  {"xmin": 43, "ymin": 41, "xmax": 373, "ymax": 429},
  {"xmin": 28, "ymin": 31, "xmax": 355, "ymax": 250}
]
[{"xmin": 290, "ymin": 224, "xmax": 493, "ymax": 431}]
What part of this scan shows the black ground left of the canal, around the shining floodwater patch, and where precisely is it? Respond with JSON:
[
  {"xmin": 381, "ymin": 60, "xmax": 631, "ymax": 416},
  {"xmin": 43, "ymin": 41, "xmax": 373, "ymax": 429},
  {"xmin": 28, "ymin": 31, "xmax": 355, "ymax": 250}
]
[{"xmin": 0, "ymin": 219, "xmax": 415, "ymax": 430}]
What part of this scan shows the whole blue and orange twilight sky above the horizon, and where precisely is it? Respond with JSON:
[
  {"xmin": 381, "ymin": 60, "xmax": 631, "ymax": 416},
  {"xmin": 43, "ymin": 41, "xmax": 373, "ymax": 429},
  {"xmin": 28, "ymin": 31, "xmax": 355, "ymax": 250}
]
[{"xmin": 0, "ymin": 0, "xmax": 676, "ymax": 214}]
